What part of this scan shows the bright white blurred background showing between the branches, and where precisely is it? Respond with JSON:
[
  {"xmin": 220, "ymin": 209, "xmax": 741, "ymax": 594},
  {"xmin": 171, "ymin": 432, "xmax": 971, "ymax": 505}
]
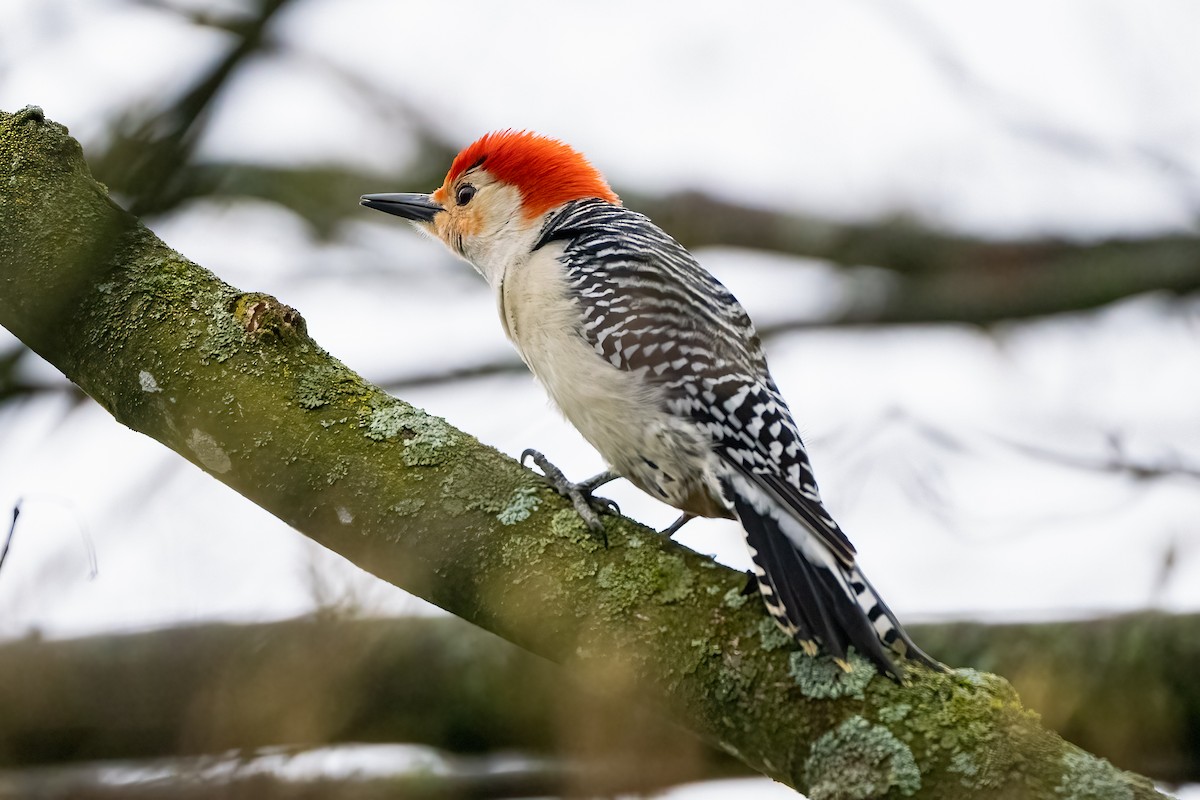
[{"xmin": 0, "ymin": 0, "xmax": 1200, "ymax": 799}]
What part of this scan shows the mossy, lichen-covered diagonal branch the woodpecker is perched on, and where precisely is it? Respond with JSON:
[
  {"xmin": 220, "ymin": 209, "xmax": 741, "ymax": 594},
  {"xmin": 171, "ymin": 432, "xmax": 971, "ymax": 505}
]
[{"xmin": 0, "ymin": 109, "xmax": 1157, "ymax": 800}]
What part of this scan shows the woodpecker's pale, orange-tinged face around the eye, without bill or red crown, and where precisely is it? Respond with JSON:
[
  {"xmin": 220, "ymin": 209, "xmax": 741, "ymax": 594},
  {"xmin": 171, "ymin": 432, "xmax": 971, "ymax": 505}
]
[{"xmin": 416, "ymin": 168, "xmax": 538, "ymax": 284}]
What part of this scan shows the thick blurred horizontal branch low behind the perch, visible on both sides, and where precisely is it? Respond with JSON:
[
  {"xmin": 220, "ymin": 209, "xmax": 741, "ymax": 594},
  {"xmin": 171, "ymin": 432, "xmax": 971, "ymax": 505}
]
[{"xmin": 0, "ymin": 614, "xmax": 1200, "ymax": 792}]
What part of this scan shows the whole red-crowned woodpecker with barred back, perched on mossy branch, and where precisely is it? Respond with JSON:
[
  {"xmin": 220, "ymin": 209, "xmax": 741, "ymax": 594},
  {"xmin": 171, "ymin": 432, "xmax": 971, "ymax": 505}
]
[{"xmin": 360, "ymin": 128, "xmax": 944, "ymax": 681}]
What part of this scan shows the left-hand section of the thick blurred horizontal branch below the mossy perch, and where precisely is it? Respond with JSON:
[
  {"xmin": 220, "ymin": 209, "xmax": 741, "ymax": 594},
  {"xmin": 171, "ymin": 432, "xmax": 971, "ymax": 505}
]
[{"xmin": 0, "ymin": 615, "xmax": 749, "ymax": 795}]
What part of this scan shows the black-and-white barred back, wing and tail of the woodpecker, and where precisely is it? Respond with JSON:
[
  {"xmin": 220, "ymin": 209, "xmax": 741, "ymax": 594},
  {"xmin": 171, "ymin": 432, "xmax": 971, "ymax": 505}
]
[{"xmin": 534, "ymin": 199, "xmax": 941, "ymax": 678}]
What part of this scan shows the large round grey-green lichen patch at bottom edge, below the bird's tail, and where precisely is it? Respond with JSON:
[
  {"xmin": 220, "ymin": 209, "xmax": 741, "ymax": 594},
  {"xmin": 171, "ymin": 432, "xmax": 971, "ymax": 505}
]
[{"xmin": 804, "ymin": 715, "xmax": 920, "ymax": 800}]
